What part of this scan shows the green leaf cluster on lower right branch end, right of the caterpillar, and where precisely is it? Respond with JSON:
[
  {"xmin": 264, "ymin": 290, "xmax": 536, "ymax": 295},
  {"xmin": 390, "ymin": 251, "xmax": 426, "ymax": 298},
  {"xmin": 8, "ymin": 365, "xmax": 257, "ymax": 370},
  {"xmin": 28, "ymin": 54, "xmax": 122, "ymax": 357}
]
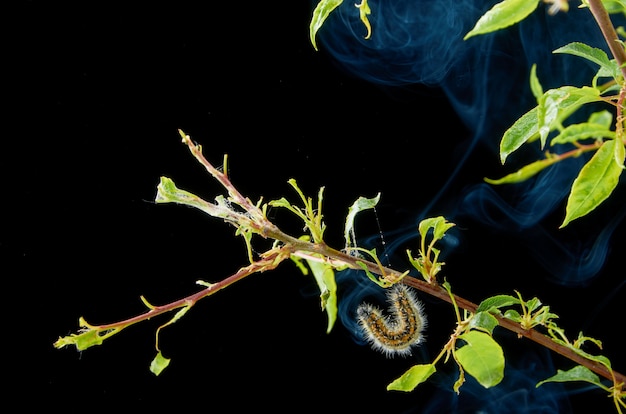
[{"xmin": 387, "ymin": 270, "xmax": 626, "ymax": 413}]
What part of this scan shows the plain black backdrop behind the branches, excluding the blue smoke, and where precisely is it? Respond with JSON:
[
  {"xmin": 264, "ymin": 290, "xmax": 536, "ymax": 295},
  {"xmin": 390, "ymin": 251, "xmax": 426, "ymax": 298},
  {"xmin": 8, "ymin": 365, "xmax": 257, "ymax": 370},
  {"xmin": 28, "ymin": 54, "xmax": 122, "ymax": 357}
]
[{"xmin": 6, "ymin": 1, "xmax": 625, "ymax": 413}]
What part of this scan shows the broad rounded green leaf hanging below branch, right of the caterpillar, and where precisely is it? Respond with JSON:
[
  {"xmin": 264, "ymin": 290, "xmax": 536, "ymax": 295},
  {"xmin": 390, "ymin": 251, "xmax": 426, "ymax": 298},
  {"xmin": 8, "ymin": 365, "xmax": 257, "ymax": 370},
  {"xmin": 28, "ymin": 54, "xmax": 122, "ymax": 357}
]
[{"xmin": 455, "ymin": 331, "xmax": 504, "ymax": 388}]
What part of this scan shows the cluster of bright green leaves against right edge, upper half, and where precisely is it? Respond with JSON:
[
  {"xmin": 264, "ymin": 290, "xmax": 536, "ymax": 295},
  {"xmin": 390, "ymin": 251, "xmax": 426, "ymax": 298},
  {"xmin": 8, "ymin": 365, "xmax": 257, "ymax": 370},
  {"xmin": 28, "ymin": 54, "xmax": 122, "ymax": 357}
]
[{"xmin": 485, "ymin": 42, "xmax": 626, "ymax": 228}]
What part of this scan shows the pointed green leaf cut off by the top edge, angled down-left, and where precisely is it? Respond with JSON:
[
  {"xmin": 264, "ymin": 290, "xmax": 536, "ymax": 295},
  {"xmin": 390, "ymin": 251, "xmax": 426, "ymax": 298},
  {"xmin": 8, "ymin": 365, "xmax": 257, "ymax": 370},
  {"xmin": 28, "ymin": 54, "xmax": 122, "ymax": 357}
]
[{"xmin": 463, "ymin": 0, "xmax": 539, "ymax": 40}]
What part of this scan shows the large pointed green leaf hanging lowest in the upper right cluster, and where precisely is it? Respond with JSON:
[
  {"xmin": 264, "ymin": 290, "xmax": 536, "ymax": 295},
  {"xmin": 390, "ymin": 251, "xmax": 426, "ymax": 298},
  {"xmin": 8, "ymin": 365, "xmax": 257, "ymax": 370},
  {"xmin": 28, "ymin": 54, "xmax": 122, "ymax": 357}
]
[{"xmin": 559, "ymin": 139, "xmax": 624, "ymax": 228}]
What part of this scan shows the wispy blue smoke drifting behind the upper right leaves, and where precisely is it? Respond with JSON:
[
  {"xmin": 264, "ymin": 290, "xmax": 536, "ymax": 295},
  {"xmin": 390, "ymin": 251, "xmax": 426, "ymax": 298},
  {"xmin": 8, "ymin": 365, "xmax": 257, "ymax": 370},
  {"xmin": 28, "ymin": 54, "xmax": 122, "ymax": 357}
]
[{"xmin": 319, "ymin": 0, "xmax": 623, "ymax": 284}]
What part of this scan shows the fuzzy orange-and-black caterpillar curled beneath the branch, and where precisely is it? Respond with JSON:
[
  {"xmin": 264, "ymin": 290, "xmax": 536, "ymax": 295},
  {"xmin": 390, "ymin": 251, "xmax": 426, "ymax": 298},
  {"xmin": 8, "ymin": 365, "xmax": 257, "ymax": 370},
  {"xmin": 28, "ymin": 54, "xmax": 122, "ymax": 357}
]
[{"xmin": 356, "ymin": 284, "xmax": 427, "ymax": 357}]
